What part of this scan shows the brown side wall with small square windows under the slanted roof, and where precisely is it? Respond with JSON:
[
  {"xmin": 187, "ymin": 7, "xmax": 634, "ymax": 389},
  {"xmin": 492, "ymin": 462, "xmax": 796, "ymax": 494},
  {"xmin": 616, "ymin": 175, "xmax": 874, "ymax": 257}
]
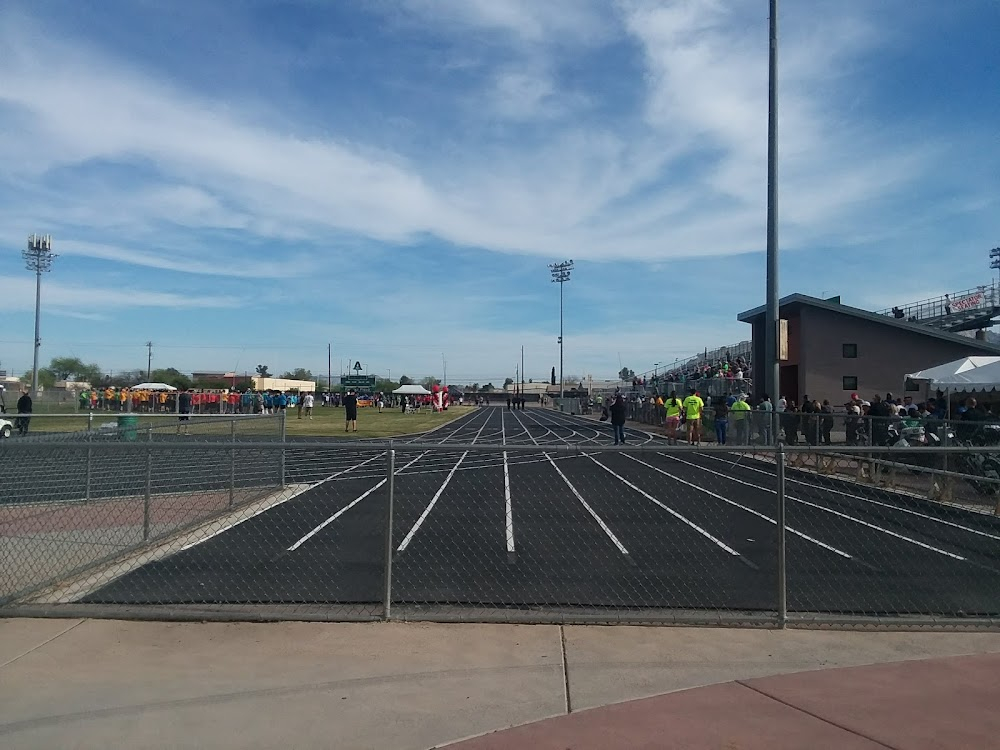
[{"xmin": 789, "ymin": 305, "xmax": 984, "ymax": 404}]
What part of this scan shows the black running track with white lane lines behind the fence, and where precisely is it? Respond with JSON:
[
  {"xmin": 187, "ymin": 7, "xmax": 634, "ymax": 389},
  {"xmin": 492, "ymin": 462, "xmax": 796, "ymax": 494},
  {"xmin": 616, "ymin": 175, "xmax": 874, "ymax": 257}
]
[{"xmin": 85, "ymin": 407, "xmax": 1000, "ymax": 616}]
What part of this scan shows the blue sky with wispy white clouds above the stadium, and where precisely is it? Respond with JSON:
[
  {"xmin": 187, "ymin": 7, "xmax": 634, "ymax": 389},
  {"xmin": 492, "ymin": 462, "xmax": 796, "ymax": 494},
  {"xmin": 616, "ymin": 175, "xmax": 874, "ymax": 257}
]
[{"xmin": 0, "ymin": 0, "xmax": 1000, "ymax": 383}]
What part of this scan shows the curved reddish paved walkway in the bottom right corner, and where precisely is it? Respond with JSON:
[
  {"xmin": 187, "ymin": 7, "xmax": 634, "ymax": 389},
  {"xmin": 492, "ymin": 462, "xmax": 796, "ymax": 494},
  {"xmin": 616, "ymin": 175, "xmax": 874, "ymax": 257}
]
[{"xmin": 448, "ymin": 654, "xmax": 1000, "ymax": 750}]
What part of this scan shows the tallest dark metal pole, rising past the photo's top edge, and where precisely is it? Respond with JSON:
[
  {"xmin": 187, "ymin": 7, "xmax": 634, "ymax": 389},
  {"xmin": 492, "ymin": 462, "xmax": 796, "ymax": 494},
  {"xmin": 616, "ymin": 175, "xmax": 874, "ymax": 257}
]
[{"xmin": 758, "ymin": 0, "xmax": 781, "ymax": 403}]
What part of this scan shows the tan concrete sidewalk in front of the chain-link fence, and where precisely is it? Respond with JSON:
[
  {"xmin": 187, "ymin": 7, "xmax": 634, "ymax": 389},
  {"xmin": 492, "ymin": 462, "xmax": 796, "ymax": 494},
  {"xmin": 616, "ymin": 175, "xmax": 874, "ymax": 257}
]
[{"xmin": 0, "ymin": 620, "xmax": 1000, "ymax": 750}]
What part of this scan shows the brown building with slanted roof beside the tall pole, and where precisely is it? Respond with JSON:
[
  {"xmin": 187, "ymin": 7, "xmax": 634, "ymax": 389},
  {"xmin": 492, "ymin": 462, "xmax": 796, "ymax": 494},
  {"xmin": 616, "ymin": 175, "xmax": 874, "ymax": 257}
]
[{"xmin": 737, "ymin": 294, "xmax": 1000, "ymax": 405}]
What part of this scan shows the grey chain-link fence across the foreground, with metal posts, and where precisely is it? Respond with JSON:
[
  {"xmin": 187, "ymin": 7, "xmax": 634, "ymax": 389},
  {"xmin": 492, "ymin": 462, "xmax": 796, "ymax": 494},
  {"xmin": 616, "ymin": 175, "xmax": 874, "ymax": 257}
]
[{"xmin": 0, "ymin": 432, "xmax": 1000, "ymax": 628}]
